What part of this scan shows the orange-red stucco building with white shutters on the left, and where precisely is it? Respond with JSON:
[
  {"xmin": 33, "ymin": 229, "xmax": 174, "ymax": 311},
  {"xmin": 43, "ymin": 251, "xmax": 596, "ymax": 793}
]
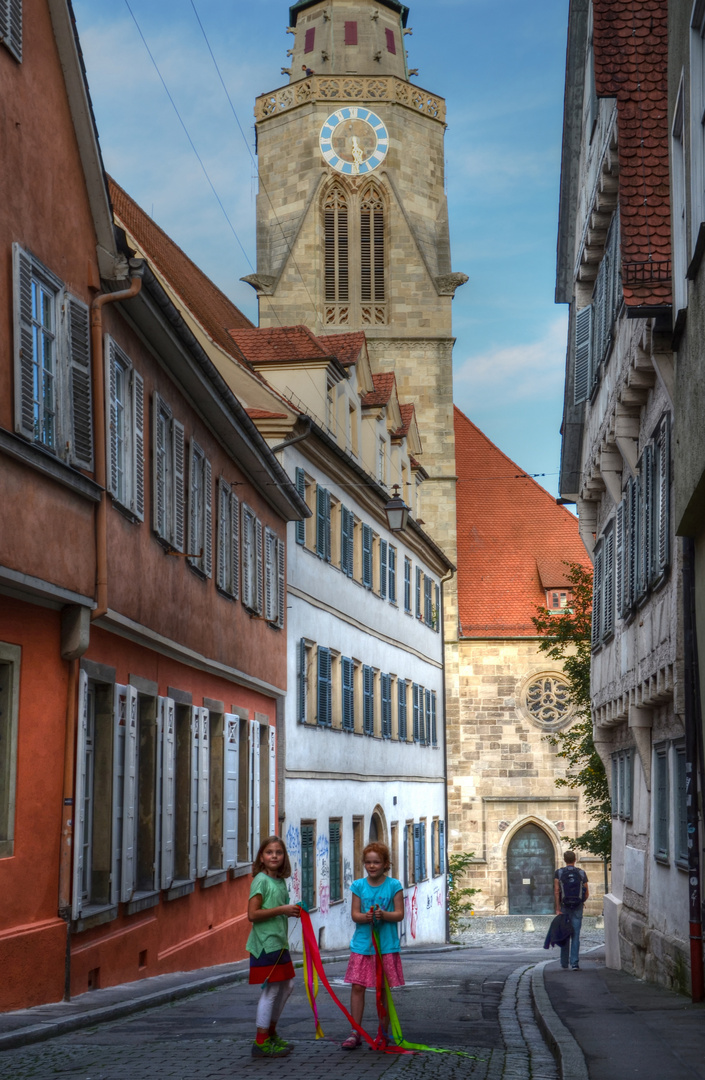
[{"xmin": 0, "ymin": 0, "xmax": 308, "ymax": 1010}]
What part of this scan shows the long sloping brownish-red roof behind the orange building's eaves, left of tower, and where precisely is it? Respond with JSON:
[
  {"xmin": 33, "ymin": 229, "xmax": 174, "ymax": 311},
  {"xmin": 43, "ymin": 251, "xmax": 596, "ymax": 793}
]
[{"xmin": 108, "ymin": 177, "xmax": 253, "ymax": 361}]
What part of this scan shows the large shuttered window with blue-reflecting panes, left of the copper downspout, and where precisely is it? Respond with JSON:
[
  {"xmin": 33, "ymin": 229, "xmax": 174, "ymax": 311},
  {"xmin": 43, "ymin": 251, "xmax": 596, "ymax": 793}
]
[{"xmin": 12, "ymin": 244, "xmax": 93, "ymax": 470}]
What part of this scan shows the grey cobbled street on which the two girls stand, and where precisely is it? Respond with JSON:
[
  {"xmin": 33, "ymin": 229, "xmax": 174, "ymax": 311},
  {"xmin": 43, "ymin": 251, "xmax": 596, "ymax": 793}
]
[{"xmin": 0, "ymin": 933, "xmax": 601, "ymax": 1080}]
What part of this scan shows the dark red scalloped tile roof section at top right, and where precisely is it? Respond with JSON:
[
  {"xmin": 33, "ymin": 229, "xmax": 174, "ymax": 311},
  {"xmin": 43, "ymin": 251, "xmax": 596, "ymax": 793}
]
[{"xmin": 593, "ymin": 0, "xmax": 672, "ymax": 307}]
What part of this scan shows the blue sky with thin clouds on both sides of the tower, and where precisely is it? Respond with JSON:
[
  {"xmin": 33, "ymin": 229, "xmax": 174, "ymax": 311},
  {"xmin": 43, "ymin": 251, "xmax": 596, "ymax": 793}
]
[{"xmin": 73, "ymin": 0, "xmax": 568, "ymax": 494}]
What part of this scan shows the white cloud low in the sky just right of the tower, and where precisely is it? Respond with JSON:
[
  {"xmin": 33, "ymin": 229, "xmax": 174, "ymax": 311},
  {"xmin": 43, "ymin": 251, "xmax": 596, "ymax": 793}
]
[{"xmin": 453, "ymin": 315, "xmax": 567, "ymax": 411}]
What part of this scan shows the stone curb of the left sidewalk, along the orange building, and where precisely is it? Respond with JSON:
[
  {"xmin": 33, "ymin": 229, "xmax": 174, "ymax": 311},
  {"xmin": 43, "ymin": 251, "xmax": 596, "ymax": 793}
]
[{"xmin": 0, "ymin": 945, "xmax": 465, "ymax": 1052}]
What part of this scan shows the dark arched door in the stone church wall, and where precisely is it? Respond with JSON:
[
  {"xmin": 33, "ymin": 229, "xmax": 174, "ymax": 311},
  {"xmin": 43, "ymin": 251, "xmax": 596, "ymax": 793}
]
[{"xmin": 506, "ymin": 824, "xmax": 556, "ymax": 915}]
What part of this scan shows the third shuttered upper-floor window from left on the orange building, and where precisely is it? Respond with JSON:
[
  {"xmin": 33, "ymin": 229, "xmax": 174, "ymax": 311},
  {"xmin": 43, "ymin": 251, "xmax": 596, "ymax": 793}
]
[{"xmin": 152, "ymin": 394, "xmax": 186, "ymax": 551}]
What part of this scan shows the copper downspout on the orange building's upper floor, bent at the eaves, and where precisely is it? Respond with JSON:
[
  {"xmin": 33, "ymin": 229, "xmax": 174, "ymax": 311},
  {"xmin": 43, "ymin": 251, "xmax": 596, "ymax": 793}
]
[{"xmin": 91, "ymin": 259, "xmax": 145, "ymax": 620}]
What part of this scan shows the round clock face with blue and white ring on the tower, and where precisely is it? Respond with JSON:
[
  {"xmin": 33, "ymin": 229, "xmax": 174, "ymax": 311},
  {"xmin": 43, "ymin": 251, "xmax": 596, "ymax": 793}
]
[{"xmin": 318, "ymin": 105, "xmax": 389, "ymax": 176}]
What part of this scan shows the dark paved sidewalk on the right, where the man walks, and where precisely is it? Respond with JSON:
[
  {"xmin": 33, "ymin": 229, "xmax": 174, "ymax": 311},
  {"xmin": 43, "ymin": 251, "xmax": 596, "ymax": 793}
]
[{"xmin": 539, "ymin": 948, "xmax": 705, "ymax": 1080}]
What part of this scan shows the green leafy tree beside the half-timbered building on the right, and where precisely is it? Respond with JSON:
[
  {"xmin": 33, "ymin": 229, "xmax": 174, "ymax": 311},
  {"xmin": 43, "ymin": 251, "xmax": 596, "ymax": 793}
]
[{"xmin": 532, "ymin": 563, "xmax": 612, "ymax": 861}]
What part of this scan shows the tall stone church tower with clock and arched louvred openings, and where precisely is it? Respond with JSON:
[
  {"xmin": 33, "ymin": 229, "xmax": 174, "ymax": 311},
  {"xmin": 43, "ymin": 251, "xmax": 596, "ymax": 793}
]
[{"xmin": 245, "ymin": 0, "xmax": 467, "ymax": 640}]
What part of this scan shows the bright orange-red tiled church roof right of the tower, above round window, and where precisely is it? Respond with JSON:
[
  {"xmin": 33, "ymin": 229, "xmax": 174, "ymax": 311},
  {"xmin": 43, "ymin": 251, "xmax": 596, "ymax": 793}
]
[{"xmin": 455, "ymin": 408, "xmax": 591, "ymax": 638}]
